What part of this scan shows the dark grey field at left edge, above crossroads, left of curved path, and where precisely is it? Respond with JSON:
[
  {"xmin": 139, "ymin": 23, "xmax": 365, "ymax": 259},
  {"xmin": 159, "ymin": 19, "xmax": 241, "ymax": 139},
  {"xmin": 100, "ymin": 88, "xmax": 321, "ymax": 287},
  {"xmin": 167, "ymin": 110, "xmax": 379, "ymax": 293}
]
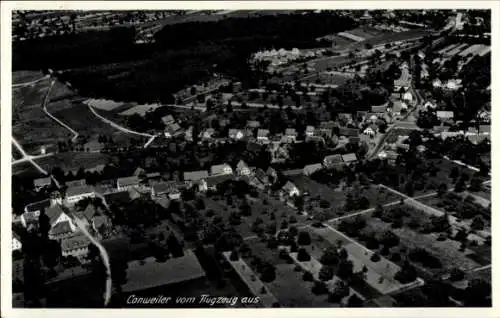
[{"xmin": 12, "ymin": 81, "xmax": 71, "ymax": 154}]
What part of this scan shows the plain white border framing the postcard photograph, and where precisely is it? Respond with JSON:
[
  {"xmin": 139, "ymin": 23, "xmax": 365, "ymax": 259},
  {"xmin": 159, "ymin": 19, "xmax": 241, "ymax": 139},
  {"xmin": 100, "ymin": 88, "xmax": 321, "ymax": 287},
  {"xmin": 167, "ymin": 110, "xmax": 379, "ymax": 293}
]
[{"xmin": 0, "ymin": 1, "xmax": 500, "ymax": 318}]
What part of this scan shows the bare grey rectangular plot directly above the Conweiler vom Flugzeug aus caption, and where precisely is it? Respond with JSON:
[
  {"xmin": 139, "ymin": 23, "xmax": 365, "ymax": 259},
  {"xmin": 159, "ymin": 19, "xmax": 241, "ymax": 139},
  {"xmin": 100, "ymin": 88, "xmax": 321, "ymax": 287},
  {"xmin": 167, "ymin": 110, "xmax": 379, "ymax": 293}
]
[{"xmin": 122, "ymin": 250, "xmax": 205, "ymax": 293}]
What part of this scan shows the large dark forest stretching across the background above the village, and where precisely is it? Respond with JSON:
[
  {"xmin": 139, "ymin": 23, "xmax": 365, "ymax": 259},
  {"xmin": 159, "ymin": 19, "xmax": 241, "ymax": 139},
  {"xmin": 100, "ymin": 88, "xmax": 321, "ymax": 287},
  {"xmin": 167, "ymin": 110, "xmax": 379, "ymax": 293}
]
[{"xmin": 13, "ymin": 12, "xmax": 356, "ymax": 103}]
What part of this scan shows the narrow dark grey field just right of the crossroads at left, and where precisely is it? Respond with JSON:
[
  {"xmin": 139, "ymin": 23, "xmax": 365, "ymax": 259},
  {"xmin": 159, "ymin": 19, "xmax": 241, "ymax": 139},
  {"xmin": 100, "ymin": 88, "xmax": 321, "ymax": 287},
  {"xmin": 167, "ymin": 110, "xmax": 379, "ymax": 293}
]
[{"xmin": 37, "ymin": 152, "xmax": 109, "ymax": 172}]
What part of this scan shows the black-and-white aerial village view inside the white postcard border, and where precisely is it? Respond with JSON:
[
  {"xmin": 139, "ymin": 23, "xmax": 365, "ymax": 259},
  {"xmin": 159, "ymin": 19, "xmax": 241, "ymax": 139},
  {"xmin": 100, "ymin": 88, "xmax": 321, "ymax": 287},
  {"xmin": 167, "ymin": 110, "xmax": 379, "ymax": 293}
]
[{"xmin": 9, "ymin": 9, "xmax": 492, "ymax": 309}]
